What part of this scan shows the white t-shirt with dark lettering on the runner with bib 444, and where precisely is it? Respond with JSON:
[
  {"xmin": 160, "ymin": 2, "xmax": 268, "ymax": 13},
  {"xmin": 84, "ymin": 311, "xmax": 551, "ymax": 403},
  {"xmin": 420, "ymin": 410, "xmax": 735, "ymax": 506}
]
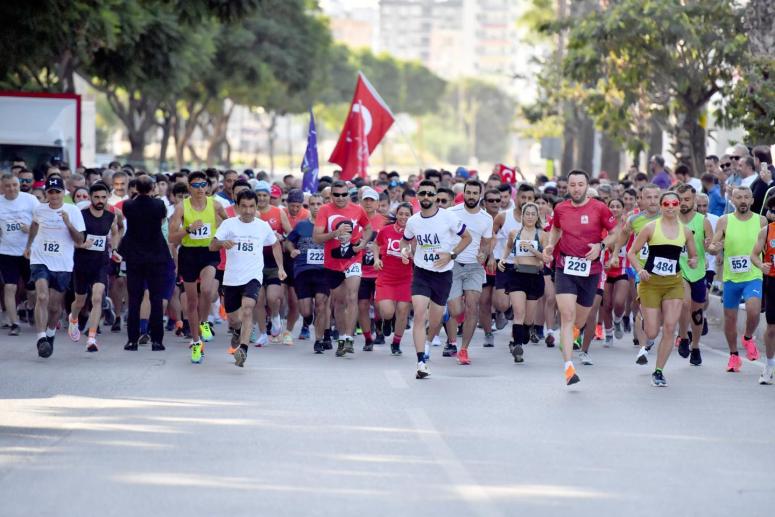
[{"xmin": 404, "ymin": 209, "xmax": 466, "ymax": 273}]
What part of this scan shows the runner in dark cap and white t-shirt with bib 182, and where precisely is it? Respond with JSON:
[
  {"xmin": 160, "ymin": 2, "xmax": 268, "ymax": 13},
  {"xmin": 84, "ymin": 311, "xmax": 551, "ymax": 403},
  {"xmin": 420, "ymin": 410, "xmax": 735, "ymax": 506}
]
[{"xmin": 24, "ymin": 175, "xmax": 86, "ymax": 358}]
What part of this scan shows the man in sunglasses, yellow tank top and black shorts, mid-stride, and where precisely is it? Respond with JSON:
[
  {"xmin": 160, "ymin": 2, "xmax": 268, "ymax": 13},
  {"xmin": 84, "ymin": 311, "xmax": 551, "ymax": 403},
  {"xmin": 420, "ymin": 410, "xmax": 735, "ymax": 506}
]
[{"xmin": 169, "ymin": 171, "xmax": 228, "ymax": 364}]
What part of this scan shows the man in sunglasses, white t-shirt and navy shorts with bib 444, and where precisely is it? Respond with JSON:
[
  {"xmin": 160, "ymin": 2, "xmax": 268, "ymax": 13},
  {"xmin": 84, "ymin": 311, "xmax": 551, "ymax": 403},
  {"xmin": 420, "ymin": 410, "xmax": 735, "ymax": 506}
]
[{"xmin": 401, "ymin": 180, "xmax": 471, "ymax": 379}]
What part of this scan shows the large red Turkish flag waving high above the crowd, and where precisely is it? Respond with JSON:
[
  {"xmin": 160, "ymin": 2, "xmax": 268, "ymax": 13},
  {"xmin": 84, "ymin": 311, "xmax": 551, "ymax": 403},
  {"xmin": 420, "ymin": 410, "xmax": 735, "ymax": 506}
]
[{"xmin": 328, "ymin": 72, "xmax": 395, "ymax": 180}]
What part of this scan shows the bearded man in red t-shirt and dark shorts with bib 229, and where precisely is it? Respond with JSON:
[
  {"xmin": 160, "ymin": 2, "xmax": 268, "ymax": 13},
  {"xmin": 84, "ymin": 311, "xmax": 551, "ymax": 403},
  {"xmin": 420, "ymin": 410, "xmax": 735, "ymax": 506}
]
[{"xmin": 544, "ymin": 170, "xmax": 617, "ymax": 385}]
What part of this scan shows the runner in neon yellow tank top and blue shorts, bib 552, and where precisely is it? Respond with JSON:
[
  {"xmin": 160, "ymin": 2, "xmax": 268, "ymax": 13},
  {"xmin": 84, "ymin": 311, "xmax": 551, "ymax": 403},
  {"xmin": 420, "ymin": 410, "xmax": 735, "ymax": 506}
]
[{"xmin": 709, "ymin": 187, "xmax": 767, "ymax": 372}]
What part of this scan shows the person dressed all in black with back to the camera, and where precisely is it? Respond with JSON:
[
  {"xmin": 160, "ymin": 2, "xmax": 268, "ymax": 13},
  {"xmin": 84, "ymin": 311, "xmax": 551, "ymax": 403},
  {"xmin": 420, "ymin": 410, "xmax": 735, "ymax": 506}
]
[{"xmin": 118, "ymin": 176, "xmax": 170, "ymax": 351}]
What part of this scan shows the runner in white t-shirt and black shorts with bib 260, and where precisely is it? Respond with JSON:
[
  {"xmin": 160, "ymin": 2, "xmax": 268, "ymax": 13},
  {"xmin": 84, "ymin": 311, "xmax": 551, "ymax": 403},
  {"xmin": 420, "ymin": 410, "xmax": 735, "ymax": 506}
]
[{"xmin": 0, "ymin": 174, "xmax": 40, "ymax": 336}]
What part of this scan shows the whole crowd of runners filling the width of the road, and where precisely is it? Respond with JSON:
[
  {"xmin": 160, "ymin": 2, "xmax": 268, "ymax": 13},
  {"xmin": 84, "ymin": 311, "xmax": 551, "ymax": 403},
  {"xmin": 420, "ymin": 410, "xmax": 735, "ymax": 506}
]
[{"xmin": 0, "ymin": 145, "xmax": 775, "ymax": 386}]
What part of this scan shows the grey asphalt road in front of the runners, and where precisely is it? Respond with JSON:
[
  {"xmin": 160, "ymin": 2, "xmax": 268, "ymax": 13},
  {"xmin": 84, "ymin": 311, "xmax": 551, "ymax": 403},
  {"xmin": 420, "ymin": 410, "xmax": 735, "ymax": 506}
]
[{"xmin": 0, "ymin": 314, "xmax": 775, "ymax": 517}]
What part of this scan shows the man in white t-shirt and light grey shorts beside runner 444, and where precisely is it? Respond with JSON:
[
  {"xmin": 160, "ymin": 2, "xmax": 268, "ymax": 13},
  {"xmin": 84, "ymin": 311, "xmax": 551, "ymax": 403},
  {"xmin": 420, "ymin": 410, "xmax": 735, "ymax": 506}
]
[{"xmin": 442, "ymin": 180, "xmax": 492, "ymax": 365}]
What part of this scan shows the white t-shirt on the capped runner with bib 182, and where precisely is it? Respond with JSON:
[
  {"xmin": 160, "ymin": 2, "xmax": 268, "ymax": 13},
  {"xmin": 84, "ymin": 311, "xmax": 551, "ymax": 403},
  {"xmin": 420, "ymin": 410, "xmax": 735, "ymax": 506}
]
[{"xmin": 30, "ymin": 204, "xmax": 86, "ymax": 273}]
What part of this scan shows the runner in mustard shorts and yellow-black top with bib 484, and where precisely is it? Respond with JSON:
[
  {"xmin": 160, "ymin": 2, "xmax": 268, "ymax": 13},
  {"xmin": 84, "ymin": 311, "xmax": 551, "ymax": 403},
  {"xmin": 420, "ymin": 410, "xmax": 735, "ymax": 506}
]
[{"xmin": 627, "ymin": 192, "xmax": 697, "ymax": 387}]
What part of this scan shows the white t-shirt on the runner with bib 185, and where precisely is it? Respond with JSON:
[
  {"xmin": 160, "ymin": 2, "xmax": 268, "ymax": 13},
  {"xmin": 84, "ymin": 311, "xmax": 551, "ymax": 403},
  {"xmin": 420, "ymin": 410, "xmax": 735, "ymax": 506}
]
[{"xmin": 215, "ymin": 217, "xmax": 277, "ymax": 286}]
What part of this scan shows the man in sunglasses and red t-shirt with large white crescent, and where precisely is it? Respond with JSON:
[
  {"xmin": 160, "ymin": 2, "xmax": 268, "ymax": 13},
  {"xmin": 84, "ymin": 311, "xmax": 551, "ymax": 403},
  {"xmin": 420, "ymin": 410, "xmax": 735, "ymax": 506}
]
[{"xmin": 312, "ymin": 180, "xmax": 372, "ymax": 357}]
